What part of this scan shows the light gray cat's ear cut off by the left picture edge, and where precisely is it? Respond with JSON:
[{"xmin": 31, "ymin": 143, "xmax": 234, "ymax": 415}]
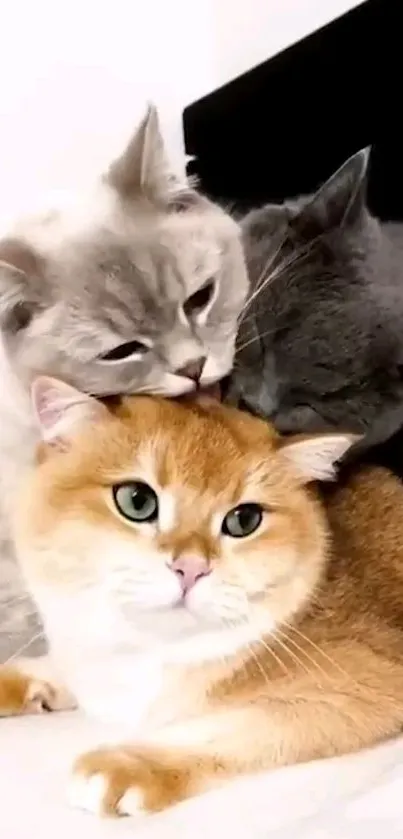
[{"xmin": 0, "ymin": 239, "xmax": 43, "ymax": 333}]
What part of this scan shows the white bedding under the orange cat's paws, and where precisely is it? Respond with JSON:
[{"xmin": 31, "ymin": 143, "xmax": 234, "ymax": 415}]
[{"xmin": 0, "ymin": 713, "xmax": 403, "ymax": 839}]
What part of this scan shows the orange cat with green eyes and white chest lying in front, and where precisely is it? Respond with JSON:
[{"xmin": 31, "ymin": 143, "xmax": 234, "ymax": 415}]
[{"xmin": 6, "ymin": 379, "xmax": 403, "ymax": 814}]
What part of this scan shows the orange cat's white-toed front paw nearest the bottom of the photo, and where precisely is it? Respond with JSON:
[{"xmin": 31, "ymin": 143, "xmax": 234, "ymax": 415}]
[{"xmin": 69, "ymin": 747, "xmax": 189, "ymax": 816}]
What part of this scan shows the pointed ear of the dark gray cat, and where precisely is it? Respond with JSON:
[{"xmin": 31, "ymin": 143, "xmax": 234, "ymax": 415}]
[{"xmin": 295, "ymin": 147, "xmax": 371, "ymax": 235}]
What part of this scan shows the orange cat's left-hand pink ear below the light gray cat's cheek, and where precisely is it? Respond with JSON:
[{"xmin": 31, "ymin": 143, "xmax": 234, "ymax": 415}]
[{"xmin": 31, "ymin": 376, "xmax": 108, "ymax": 449}]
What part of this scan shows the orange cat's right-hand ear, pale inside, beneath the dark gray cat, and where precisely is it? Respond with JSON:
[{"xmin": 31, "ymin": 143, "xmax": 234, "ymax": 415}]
[{"xmin": 281, "ymin": 433, "xmax": 361, "ymax": 483}]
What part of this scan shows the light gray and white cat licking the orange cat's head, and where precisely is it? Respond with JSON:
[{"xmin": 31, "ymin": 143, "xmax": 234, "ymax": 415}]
[{"xmin": 0, "ymin": 108, "xmax": 247, "ymax": 661}]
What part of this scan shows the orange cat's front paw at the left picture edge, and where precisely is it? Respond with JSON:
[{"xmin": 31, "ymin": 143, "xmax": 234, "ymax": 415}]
[{"xmin": 0, "ymin": 667, "xmax": 74, "ymax": 717}]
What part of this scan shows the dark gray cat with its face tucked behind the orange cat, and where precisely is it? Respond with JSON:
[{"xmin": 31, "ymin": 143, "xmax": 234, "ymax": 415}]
[{"xmin": 231, "ymin": 150, "xmax": 403, "ymax": 456}]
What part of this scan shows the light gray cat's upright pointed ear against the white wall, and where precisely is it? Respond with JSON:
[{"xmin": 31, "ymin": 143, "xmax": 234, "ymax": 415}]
[{"xmin": 105, "ymin": 105, "xmax": 191, "ymax": 204}]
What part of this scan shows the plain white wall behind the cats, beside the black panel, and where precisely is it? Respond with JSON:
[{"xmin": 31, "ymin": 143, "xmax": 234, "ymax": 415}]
[{"xmin": 0, "ymin": 0, "xmax": 364, "ymax": 220}]
